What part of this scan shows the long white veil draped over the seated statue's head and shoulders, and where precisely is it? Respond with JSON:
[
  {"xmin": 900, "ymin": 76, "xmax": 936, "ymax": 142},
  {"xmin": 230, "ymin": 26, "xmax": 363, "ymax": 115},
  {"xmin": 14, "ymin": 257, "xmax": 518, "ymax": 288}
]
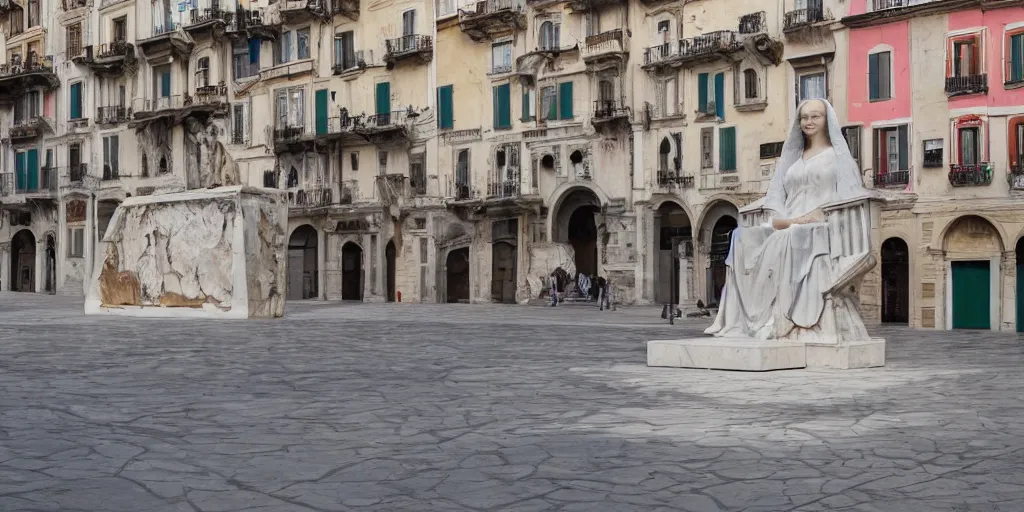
[{"xmin": 764, "ymin": 99, "xmax": 867, "ymax": 216}]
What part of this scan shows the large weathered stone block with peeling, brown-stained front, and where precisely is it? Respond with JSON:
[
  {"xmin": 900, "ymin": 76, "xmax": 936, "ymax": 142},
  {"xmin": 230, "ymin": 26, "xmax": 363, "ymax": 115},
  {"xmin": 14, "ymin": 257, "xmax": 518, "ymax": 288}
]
[{"xmin": 85, "ymin": 186, "xmax": 288, "ymax": 318}]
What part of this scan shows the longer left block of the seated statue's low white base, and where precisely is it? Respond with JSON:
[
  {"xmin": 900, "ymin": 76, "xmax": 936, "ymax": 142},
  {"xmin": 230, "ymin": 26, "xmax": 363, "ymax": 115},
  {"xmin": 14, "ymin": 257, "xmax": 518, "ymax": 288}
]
[{"xmin": 647, "ymin": 337, "xmax": 807, "ymax": 372}]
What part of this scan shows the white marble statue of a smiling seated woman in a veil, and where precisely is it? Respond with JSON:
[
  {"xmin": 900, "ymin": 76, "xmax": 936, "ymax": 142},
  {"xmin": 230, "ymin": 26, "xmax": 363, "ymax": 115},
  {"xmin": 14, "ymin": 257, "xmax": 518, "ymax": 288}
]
[{"xmin": 705, "ymin": 99, "xmax": 867, "ymax": 342}]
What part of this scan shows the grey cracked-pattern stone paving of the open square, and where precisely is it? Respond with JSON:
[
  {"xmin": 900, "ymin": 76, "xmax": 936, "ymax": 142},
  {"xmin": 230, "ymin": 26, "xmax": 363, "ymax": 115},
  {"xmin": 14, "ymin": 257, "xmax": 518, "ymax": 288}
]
[{"xmin": 0, "ymin": 294, "xmax": 1024, "ymax": 512}]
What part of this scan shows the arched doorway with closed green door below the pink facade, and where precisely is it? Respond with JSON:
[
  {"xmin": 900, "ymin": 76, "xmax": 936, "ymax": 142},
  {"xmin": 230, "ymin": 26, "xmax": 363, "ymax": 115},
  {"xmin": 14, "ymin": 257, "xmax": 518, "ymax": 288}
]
[{"xmin": 943, "ymin": 215, "xmax": 1002, "ymax": 329}]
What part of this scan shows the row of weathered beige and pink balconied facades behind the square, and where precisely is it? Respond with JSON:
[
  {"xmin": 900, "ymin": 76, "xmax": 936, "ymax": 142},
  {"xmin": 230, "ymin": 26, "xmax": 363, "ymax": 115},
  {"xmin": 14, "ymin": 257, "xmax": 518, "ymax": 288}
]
[{"xmin": 6, "ymin": 0, "xmax": 1024, "ymax": 330}]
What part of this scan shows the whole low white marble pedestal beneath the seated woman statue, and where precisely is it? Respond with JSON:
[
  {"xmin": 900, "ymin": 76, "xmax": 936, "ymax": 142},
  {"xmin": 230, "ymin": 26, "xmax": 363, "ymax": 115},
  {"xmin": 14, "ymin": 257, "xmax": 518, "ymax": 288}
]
[{"xmin": 647, "ymin": 336, "xmax": 886, "ymax": 372}]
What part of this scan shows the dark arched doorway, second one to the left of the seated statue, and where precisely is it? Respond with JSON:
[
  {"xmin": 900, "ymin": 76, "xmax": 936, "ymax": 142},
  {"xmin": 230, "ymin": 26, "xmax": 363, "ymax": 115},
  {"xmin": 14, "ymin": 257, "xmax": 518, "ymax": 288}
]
[{"xmin": 653, "ymin": 201, "xmax": 693, "ymax": 304}]
